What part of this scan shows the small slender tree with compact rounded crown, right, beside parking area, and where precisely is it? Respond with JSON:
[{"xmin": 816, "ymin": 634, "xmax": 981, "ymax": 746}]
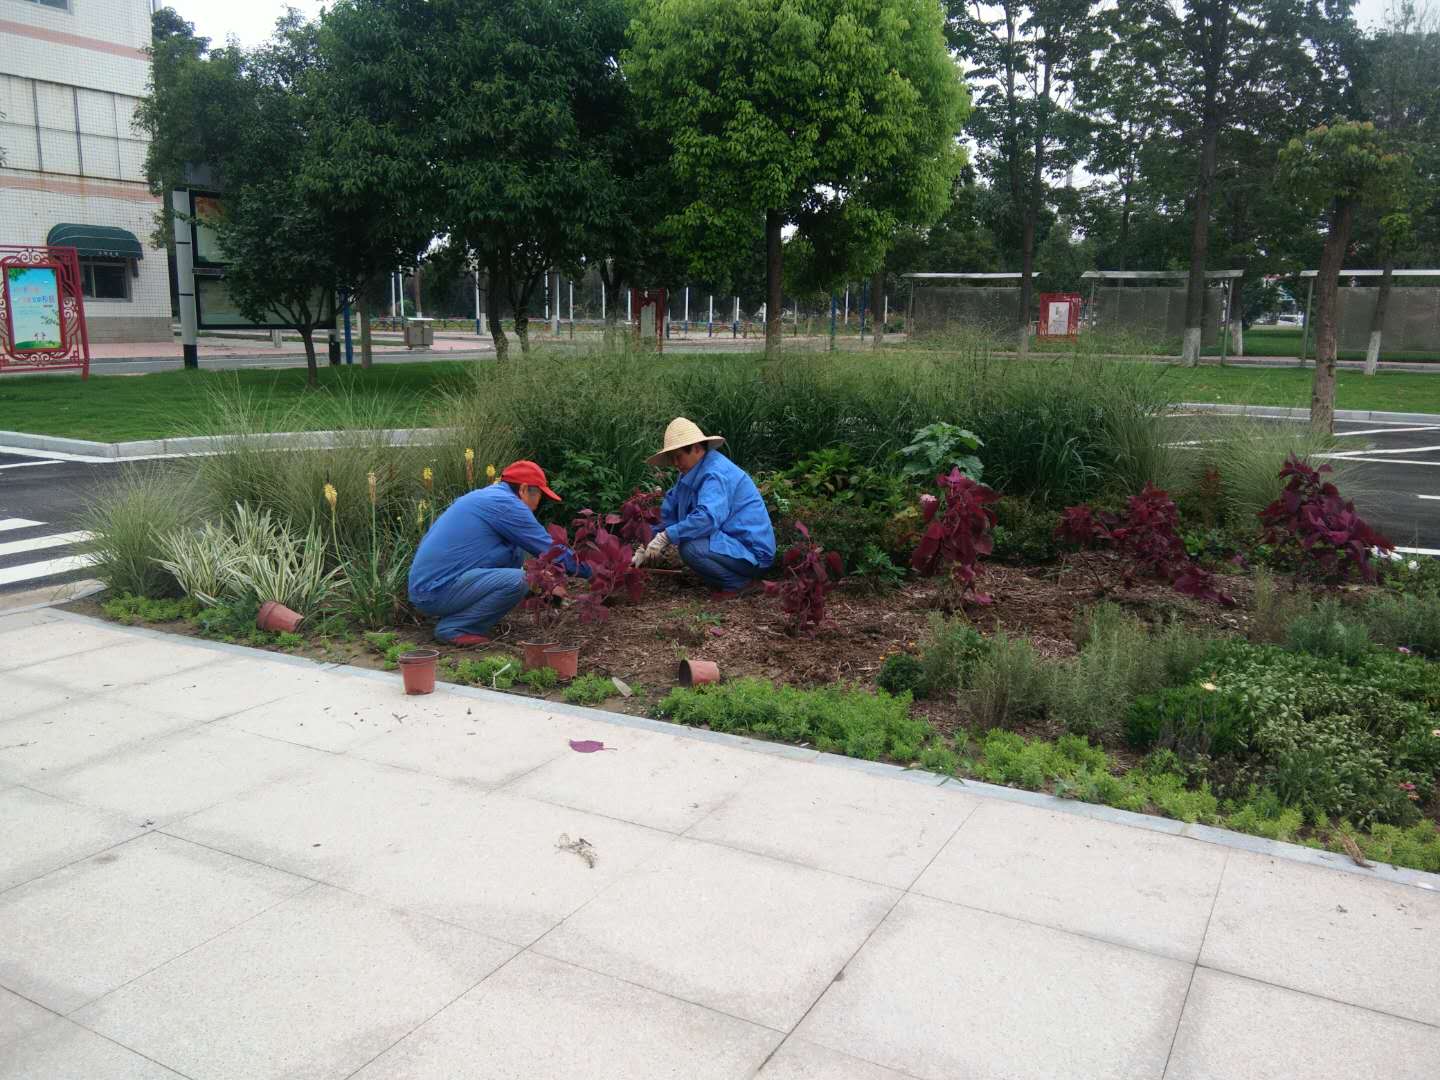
[{"xmin": 1280, "ymin": 120, "xmax": 1410, "ymax": 433}]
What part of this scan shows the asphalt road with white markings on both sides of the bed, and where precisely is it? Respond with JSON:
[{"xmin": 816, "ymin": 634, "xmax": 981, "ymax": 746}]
[{"xmin": 8, "ymin": 419, "xmax": 1440, "ymax": 593}]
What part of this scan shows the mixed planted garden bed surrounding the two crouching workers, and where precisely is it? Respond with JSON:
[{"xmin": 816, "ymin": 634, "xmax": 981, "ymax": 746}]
[{"xmin": 81, "ymin": 353, "xmax": 1440, "ymax": 865}]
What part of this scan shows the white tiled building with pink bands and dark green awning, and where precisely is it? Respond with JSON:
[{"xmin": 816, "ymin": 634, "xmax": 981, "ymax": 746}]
[{"xmin": 0, "ymin": 0, "xmax": 171, "ymax": 343}]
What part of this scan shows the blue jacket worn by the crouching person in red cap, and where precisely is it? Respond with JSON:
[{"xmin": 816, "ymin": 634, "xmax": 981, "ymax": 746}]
[{"xmin": 410, "ymin": 484, "xmax": 589, "ymax": 600}]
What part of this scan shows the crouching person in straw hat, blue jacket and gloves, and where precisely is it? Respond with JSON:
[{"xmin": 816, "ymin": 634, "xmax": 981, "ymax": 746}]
[{"xmin": 634, "ymin": 416, "xmax": 775, "ymax": 600}]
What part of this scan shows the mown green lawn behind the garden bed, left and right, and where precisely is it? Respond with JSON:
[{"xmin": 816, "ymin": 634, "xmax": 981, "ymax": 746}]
[{"xmin": 0, "ymin": 352, "xmax": 1440, "ymax": 442}]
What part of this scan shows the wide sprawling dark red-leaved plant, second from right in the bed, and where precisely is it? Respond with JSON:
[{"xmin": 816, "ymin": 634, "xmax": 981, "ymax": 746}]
[{"xmin": 1056, "ymin": 484, "xmax": 1234, "ymax": 608}]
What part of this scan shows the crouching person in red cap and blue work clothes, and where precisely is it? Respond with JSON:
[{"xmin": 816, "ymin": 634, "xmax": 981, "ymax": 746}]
[{"xmin": 409, "ymin": 461, "xmax": 590, "ymax": 645}]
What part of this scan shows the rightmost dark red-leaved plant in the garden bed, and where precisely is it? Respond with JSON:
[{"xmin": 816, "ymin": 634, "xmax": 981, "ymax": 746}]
[{"xmin": 1260, "ymin": 454, "xmax": 1395, "ymax": 585}]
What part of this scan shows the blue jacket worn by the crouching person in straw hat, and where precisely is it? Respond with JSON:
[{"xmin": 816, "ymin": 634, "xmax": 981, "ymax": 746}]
[{"xmin": 660, "ymin": 449, "xmax": 775, "ymax": 570}]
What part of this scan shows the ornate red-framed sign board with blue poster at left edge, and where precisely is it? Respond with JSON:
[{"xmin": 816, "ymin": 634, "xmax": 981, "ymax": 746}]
[{"xmin": 0, "ymin": 245, "xmax": 89, "ymax": 379}]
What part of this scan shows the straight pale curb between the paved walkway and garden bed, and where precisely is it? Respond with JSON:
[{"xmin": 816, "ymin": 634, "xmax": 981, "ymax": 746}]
[{"xmin": 30, "ymin": 609, "xmax": 1440, "ymax": 893}]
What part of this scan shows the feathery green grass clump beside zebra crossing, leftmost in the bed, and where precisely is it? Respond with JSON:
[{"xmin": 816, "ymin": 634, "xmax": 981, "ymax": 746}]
[{"xmin": 79, "ymin": 462, "xmax": 194, "ymax": 598}]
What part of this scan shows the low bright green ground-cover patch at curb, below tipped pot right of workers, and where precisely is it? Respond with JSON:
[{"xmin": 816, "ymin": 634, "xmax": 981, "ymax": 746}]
[{"xmin": 660, "ymin": 678, "xmax": 933, "ymax": 765}]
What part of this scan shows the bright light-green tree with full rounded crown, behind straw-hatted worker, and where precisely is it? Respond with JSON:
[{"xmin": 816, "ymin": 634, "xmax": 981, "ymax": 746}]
[{"xmin": 625, "ymin": 0, "xmax": 966, "ymax": 351}]
